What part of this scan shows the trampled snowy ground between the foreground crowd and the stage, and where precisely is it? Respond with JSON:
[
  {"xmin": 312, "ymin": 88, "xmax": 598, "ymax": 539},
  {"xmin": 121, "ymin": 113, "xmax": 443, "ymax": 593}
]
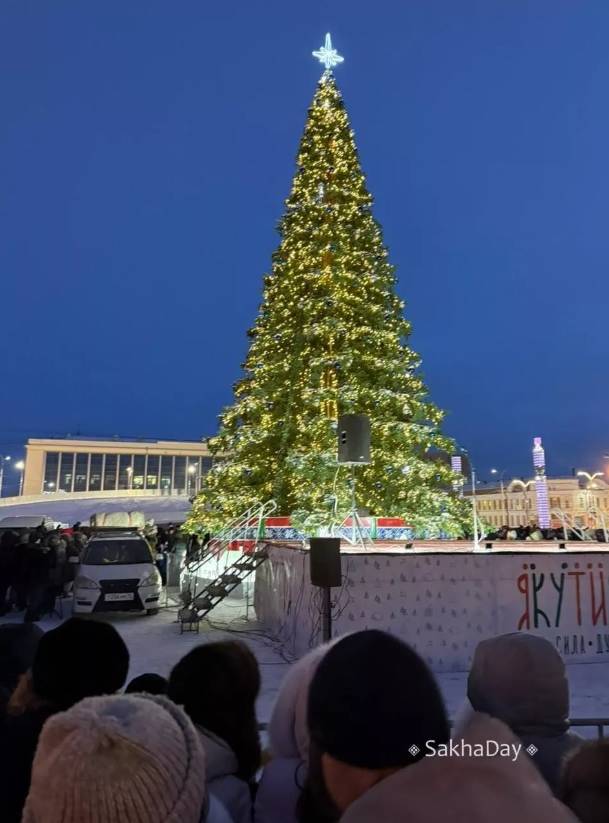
[{"xmin": 5, "ymin": 597, "xmax": 609, "ymax": 736}]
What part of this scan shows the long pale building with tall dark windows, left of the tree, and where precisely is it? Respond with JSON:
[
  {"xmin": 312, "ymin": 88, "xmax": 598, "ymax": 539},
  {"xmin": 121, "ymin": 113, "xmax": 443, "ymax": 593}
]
[{"xmin": 23, "ymin": 438, "xmax": 212, "ymax": 495}]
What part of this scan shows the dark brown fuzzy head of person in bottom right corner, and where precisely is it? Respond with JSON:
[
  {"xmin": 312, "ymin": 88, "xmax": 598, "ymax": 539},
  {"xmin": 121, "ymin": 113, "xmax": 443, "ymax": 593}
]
[{"xmin": 558, "ymin": 740, "xmax": 609, "ymax": 823}]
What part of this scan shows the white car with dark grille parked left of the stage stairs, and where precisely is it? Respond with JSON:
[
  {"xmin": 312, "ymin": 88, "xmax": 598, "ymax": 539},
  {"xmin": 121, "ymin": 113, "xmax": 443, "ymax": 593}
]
[{"xmin": 74, "ymin": 530, "xmax": 162, "ymax": 614}]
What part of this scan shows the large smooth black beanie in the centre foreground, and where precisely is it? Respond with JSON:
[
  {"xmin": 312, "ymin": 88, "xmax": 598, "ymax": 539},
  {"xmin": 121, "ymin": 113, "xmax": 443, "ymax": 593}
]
[{"xmin": 308, "ymin": 629, "xmax": 450, "ymax": 769}]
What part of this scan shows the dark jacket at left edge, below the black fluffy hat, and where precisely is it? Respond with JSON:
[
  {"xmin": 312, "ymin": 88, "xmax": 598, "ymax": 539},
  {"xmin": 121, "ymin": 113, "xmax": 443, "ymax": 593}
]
[{"xmin": 0, "ymin": 707, "xmax": 53, "ymax": 823}]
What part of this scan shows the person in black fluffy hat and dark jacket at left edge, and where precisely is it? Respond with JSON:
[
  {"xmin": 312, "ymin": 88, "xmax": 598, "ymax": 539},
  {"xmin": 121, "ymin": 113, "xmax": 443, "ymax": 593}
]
[{"xmin": 0, "ymin": 618, "xmax": 129, "ymax": 823}]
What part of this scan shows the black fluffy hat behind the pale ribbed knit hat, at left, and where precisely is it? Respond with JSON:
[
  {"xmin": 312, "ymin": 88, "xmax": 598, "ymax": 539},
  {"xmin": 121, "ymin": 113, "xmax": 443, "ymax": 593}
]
[{"xmin": 32, "ymin": 617, "xmax": 129, "ymax": 709}]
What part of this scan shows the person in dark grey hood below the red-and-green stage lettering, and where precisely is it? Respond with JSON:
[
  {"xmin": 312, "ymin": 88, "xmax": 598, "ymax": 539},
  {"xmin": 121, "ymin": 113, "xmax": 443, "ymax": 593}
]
[{"xmin": 467, "ymin": 632, "xmax": 582, "ymax": 793}]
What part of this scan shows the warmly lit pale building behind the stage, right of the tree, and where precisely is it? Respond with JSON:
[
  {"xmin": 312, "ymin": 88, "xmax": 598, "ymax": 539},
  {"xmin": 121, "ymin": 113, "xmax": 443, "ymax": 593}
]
[{"xmin": 468, "ymin": 477, "xmax": 609, "ymax": 530}]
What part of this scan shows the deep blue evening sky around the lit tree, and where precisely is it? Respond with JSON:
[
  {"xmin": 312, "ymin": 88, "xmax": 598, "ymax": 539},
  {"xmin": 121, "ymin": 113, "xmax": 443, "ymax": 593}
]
[{"xmin": 0, "ymin": 0, "xmax": 609, "ymax": 490}]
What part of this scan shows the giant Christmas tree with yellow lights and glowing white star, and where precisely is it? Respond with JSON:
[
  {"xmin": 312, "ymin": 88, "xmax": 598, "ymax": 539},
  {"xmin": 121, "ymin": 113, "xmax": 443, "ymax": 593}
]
[{"xmin": 187, "ymin": 37, "xmax": 465, "ymax": 534}]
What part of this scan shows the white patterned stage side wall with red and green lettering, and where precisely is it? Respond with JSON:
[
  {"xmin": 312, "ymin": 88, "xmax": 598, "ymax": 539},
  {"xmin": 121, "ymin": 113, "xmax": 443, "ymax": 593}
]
[{"xmin": 254, "ymin": 541, "xmax": 609, "ymax": 672}]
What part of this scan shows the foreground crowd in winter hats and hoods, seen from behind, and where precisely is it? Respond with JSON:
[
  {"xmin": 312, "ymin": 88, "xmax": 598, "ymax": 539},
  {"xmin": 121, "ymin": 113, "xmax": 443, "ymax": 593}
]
[{"xmin": 0, "ymin": 618, "xmax": 609, "ymax": 823}]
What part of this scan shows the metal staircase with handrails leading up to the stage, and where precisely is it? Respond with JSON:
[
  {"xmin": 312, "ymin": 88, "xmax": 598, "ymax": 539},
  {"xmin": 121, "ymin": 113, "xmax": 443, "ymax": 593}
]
[{"xmin": 178, "ymin": 500, "xmax": 277, "ymax": 633}]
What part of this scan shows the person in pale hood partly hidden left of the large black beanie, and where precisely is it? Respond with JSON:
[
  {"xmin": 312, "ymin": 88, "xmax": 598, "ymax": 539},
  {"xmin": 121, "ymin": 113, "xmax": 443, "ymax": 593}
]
[{"xmin": 254, "ymin": 645, "xmax": 329, "ymax": 823}]
